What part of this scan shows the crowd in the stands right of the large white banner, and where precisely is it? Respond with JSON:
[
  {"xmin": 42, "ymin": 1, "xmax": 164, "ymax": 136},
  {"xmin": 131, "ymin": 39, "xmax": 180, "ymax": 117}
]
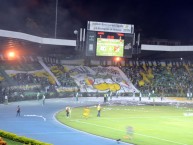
[{"xmin": 121, "ymin": 61, "xmax": 193, "ymax": 96}]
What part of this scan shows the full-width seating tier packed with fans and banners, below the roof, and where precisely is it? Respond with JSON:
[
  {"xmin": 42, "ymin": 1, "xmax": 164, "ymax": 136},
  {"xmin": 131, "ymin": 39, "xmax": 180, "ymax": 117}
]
[{"xmin": 0, "ymin": 58, "xmax": 193, "ymax": 101}]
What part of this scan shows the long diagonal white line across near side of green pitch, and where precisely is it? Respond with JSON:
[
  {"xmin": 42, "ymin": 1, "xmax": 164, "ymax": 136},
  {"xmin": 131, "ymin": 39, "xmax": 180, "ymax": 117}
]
[{"xmin": 72, "ymin": 120, "xmax": 186, "ymax": 145}]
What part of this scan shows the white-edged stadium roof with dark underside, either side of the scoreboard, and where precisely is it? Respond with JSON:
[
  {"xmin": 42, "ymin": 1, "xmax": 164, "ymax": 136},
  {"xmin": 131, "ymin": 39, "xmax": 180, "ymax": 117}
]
[{"xmin": 0, "ymin": 30, "xmax": 193, "ymax": 60}]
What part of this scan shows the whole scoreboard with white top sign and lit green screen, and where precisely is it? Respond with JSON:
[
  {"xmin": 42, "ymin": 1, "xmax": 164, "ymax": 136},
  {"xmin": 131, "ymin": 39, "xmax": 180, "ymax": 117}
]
[{"xmin": 86, "ymin": 21, "xmax": 134, "ymax": 57}]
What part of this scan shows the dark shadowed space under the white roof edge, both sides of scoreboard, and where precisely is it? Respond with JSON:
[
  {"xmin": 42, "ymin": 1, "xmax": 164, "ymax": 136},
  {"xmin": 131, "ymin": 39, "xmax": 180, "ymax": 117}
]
[{"xmin": 0, "ymin": 37, "xmax": 193, "ymax": 61}]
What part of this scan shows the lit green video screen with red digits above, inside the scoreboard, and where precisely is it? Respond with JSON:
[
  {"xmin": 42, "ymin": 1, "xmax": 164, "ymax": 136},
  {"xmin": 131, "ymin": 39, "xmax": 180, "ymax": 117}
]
[{"xmin": 96, "ymin": 32, "xmax": 124, "ymax": 57}]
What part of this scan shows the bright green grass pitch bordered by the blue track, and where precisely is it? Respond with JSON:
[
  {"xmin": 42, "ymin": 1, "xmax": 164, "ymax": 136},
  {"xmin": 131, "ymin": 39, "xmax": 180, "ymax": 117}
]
[{"xmin": 56, "ymin": 106, "xmax": 193, "ymax": 145}]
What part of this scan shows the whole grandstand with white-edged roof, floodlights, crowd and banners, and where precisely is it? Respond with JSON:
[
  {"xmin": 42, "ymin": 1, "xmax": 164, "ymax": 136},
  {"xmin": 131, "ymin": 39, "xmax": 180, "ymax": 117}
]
[{"xmin": 0, "ymin": 25, "xmax": 193, "ymax": 103}]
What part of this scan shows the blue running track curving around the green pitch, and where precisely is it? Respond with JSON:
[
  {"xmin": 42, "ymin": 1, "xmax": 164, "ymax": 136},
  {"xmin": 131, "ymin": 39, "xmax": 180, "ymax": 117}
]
[{"xmin": 0, "ymin": 98, "xmax": 129, "ymax": 145}]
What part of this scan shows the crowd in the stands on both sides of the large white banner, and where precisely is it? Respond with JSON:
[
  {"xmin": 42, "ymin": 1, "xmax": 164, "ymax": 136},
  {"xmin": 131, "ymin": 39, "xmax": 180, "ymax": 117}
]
[{"xmin": 0, "ymin": 59, "xmax": 193, "ymax": 103}]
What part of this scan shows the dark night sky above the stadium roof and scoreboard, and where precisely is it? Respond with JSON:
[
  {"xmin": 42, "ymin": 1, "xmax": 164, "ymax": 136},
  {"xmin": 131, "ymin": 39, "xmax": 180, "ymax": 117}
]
[{"xmin": 0, "ymin": 0, "xmax": 193, "ymax": 40}]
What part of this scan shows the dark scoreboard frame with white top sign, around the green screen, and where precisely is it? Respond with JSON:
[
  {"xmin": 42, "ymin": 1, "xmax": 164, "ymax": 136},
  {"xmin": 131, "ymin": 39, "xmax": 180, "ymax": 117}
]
[{"xmin": 85, "ymin": 21, "xmax": 135, "ymax": 58}]
